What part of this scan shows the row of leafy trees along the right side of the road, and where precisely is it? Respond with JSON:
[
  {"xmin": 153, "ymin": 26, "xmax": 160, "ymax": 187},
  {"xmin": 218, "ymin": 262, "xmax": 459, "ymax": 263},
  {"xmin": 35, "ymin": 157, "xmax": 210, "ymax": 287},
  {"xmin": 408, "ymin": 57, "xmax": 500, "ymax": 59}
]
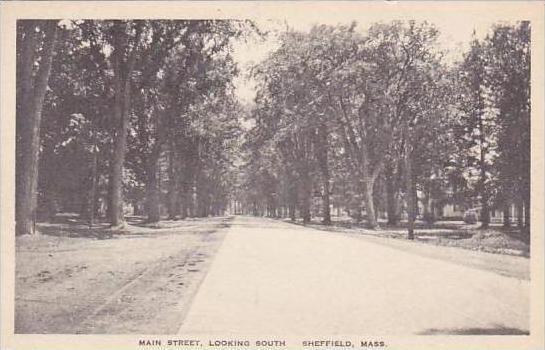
[{"xmin": 236, "ymin": 21, "xmax": 530, "ymax": 238}]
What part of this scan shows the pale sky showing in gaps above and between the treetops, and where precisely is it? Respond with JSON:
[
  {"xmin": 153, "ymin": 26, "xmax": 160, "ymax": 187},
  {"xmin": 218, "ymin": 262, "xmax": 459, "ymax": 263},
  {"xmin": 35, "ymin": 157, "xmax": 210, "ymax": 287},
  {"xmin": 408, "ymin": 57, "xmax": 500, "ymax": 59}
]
[{"xmin": 233, "ymin": 14, "xmax": 510, "ymax": 103}]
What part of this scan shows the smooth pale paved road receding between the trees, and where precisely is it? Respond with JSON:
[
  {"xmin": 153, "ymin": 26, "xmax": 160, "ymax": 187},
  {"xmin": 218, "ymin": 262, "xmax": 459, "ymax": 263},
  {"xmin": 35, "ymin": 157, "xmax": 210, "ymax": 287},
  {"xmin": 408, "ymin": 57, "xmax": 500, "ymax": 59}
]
[{"xmin": 180, "ymin": 217, "xmax": 530, "ymax": 336}]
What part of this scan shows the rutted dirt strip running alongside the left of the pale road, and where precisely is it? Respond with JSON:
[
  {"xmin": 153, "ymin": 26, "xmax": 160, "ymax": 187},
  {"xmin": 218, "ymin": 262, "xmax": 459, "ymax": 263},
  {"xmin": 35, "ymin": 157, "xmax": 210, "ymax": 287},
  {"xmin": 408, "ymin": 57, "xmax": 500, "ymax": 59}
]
[{"xmin": 15, "ymin": 218, "xmax": 229, "ymax": 334}]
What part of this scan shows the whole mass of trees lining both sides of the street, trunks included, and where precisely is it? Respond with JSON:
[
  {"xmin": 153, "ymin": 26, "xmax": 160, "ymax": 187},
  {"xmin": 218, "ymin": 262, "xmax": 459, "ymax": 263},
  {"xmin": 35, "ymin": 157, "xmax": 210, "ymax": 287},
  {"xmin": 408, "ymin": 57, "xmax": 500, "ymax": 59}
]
[{"xmin": 17, "ymin": 20, "xmax": 531, "ymax": 238}]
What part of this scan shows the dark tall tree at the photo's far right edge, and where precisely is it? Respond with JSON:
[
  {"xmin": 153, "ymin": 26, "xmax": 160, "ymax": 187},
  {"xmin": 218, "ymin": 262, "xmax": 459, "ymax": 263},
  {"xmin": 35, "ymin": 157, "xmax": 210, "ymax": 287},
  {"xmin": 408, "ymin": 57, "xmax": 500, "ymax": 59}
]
[{"xmin": 488, "ymin": 22, "xmax": 531, "ymax": 232}]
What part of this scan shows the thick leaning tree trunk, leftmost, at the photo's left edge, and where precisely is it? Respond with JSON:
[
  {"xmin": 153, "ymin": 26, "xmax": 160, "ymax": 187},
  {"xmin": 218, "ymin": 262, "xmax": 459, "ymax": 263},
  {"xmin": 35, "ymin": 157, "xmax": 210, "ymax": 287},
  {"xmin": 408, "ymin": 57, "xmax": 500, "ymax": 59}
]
[{"xmin": 15, "ymin": 21, "xmax": 57, "ymax": 235}]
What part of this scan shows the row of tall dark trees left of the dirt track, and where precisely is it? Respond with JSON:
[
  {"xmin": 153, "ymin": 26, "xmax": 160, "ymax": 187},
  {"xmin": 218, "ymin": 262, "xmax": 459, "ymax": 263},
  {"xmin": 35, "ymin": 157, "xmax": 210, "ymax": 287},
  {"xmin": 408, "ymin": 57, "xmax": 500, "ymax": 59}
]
[{"xmin": 16, "ymin": 20, "xmax": 255, "ymax": 234}]
